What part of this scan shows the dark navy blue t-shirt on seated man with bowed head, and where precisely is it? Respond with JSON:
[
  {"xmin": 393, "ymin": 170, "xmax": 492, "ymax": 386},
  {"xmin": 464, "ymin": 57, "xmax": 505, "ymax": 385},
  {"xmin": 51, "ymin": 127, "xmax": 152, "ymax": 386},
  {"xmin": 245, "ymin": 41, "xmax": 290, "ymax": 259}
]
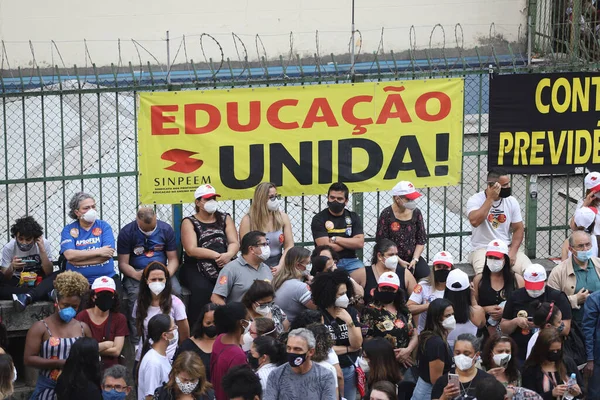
[{"xmin": 117, "ymin": 221, "xmax": 177, "ymax": 270}]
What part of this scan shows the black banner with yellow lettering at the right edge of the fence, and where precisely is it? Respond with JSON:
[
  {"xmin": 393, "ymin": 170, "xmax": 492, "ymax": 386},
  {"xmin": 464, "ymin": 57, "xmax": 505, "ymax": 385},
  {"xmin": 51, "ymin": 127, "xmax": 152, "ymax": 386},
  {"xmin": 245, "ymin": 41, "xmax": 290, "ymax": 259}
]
[{"xmin": 488, "ymin": 72, "xmax": 600, "ymax": 174}]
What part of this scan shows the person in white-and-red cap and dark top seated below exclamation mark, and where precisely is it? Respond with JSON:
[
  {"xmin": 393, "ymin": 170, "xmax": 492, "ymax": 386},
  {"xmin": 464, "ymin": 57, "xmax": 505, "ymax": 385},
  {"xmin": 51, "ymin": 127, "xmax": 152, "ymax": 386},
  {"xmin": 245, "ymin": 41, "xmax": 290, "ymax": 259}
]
[{"xmin": 375, "ymin": 181, "xmax": 429, "ymax": 282}]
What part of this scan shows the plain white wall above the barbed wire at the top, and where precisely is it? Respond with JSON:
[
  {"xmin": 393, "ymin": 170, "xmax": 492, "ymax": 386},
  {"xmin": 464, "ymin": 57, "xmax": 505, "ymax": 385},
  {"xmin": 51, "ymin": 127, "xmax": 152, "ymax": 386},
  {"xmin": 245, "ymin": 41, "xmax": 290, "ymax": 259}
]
[{"xmin": 0, "ymin": 0, "xmax": 526, "ymax": 67}]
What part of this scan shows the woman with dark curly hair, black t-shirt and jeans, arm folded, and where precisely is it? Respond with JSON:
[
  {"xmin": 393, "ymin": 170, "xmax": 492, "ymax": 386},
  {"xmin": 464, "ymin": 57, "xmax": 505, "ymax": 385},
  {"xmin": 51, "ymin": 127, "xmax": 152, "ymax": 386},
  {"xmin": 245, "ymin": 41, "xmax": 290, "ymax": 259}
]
[{"xmin": 311, "ymin": 270, "xmax": 363, "ymax": 400}]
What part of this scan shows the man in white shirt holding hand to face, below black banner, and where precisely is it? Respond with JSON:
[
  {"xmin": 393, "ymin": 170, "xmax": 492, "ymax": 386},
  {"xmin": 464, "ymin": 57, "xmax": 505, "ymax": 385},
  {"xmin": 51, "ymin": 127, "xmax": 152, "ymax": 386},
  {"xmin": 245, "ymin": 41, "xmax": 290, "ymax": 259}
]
[{"xmin": 466, "ymin": 168, "xmax": 531, "ymax": 275}]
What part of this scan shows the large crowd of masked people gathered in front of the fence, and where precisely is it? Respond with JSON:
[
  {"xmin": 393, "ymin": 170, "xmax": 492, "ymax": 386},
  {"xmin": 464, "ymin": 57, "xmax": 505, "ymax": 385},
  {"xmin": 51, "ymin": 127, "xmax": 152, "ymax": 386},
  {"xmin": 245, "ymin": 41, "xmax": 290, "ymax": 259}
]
[{"xmin": 0, "ymin": 170, "xmax": 600, "ymax": 400}]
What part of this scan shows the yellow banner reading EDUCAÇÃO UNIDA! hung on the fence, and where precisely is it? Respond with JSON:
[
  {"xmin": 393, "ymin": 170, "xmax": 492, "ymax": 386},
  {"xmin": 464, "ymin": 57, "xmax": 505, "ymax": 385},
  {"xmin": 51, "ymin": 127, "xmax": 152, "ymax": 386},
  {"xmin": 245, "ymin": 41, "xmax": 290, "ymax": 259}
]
[{"xmin": 138, "ymin": 79, "xmax": 464, "ymax": 204}]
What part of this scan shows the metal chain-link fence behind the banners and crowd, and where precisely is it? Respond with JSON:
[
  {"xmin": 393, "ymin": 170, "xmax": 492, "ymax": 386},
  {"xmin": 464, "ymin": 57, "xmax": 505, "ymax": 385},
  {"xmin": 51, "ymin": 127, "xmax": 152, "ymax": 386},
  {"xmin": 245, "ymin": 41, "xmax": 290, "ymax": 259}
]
[{"xmin": 0, "ymin": 22, "xmax": 583, "ymax": 261}]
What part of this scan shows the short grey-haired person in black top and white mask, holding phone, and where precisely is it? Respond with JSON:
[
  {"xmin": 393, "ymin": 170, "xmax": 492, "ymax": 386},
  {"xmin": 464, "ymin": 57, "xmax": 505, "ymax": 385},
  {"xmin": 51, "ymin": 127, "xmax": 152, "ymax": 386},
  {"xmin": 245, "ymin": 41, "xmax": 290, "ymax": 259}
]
[{"xmin": 431, "ymin": 333, "xmax": 493, "ymax": 400}]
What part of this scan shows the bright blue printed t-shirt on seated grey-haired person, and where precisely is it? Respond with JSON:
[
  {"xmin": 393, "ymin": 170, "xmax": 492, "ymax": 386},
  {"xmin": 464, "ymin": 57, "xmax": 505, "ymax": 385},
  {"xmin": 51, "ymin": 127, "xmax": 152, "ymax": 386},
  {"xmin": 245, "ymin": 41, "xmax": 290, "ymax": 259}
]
[{"xmin": 60, "ymin": 219, "xmax": 115, "ymax": 284}]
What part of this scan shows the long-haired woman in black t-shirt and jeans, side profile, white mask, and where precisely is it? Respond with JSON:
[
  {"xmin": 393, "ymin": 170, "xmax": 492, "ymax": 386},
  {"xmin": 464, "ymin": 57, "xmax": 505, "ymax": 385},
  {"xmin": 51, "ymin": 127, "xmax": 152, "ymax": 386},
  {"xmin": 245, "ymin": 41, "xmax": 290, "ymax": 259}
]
[{"xmin": 411, "ymin": 299, "xmax": 456, "ymax": 400}]
